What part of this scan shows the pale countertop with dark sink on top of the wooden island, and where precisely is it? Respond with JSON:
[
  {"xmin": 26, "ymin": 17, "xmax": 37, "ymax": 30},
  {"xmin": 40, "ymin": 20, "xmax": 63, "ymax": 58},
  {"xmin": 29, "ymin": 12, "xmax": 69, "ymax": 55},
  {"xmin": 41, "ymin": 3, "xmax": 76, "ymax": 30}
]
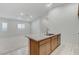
[{"xmin": 26, "ymin": 34, "xmax": 57, "ymax": 41}]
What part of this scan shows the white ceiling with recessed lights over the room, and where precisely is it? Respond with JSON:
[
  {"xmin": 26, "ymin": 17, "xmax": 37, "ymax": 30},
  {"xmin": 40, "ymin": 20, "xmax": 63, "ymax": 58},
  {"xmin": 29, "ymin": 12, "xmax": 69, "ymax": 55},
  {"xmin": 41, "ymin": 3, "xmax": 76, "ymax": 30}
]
[{"xmin": 0, "ymin": 3, "xmax": 68, "ymax": 21}]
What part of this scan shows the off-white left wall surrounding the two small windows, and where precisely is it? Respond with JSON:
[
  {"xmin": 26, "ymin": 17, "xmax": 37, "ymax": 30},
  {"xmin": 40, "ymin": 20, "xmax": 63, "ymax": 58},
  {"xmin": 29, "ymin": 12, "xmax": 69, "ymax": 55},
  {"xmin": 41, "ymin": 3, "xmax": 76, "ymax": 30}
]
[{"xmin": 0, "ymin": 19, "xmax": 29, "ymax": 54}]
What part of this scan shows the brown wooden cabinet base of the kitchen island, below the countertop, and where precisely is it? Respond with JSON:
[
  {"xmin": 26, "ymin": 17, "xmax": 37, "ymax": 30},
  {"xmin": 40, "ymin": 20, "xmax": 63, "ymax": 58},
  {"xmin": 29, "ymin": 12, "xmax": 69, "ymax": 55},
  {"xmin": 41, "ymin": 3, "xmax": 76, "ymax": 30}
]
[{"xmin": 30, "ymin": 34, "xmax": 60, "ymax": 55}]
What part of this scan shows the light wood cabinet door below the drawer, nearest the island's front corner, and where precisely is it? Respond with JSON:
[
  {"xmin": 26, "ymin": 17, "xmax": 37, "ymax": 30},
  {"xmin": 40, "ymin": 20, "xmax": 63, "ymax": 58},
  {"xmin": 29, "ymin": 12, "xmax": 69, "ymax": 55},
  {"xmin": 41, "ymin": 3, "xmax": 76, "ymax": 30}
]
[{"xmin": 40, "ymin": 42, "xmax": 51, "ymax": 55}]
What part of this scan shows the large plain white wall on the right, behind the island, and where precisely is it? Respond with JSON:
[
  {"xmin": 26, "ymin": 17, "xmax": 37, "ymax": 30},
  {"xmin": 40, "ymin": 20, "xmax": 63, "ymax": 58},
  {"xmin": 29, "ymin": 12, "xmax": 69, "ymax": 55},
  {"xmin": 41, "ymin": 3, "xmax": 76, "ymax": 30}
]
[{"xmin": 48, "ymin": 4, "xmax": 79, "ymax": 42}]
